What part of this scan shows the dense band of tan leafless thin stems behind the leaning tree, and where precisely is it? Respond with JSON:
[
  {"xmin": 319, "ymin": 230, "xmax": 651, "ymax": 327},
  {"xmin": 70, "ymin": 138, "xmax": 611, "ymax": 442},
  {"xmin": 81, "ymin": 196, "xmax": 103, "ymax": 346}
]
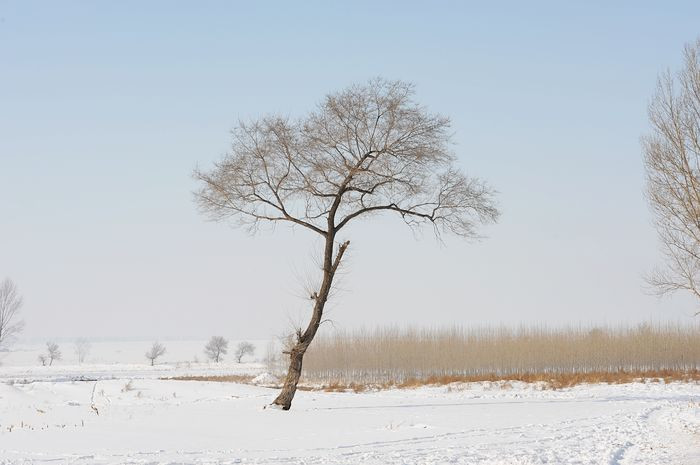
[{"xmin": 303, "ymin": 323, "xmax": 700, "ymax": 386}]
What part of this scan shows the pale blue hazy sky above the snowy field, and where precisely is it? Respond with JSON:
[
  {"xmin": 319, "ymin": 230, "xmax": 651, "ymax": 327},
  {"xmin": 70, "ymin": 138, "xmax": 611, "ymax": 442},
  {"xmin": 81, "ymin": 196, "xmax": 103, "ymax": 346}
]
[{"xmin": 0, "ymin": 1, "xmax": 700, "ymax": 338}]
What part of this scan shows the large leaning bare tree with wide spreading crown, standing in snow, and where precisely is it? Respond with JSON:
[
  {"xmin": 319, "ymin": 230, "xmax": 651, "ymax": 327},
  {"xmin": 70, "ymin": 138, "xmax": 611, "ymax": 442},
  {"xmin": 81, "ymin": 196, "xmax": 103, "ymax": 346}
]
[{"xmin": 195, "ymin": 79, "xmax": 498, "ymax": 410}]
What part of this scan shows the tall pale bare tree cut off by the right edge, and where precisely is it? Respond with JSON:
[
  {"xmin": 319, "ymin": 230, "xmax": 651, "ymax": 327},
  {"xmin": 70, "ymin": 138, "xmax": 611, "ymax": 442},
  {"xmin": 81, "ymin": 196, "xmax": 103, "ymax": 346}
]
[{"xmin": 642, "ymin": 39, "xmax": 700, "ymax": 298}]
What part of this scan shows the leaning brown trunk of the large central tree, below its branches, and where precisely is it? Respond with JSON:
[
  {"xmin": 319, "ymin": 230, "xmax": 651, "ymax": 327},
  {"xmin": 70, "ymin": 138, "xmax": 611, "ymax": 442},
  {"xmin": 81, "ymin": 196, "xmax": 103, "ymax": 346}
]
[{"xmin": 272, "ymin": 235, "xmax": 350, "ymax": 410}]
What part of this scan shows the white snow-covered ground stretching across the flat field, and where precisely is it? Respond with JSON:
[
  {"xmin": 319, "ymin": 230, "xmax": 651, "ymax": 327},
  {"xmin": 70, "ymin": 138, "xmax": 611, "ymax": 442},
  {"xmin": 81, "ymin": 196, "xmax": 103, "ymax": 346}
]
[{"xmin": 0, "ymin": 341, "xmax": 700, "ymax": 465}]
